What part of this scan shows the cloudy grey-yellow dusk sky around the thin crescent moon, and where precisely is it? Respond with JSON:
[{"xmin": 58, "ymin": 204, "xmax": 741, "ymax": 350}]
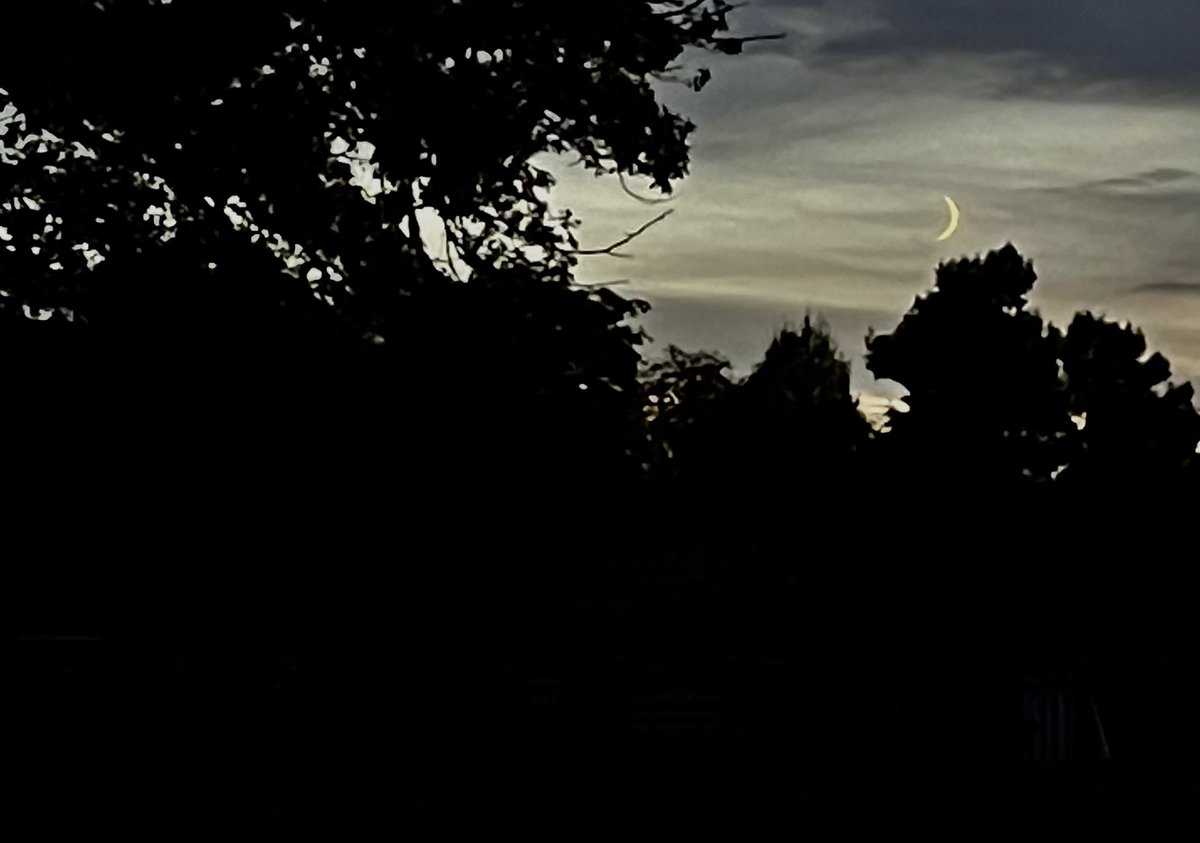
[{"xmin": 550, "ymin": 0, "xmax": 1200, "ymax": 413}]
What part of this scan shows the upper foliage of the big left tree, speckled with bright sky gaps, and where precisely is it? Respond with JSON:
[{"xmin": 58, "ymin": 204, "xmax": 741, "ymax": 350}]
[{"xmin": 0, "ymin": 0, "xmax": 737, "ymax": 314}]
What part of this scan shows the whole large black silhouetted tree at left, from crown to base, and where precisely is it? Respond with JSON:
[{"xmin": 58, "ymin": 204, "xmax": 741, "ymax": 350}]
[{"xmin": 0, "ymin": 0, "xmax": 763, "ymax": 658}]
